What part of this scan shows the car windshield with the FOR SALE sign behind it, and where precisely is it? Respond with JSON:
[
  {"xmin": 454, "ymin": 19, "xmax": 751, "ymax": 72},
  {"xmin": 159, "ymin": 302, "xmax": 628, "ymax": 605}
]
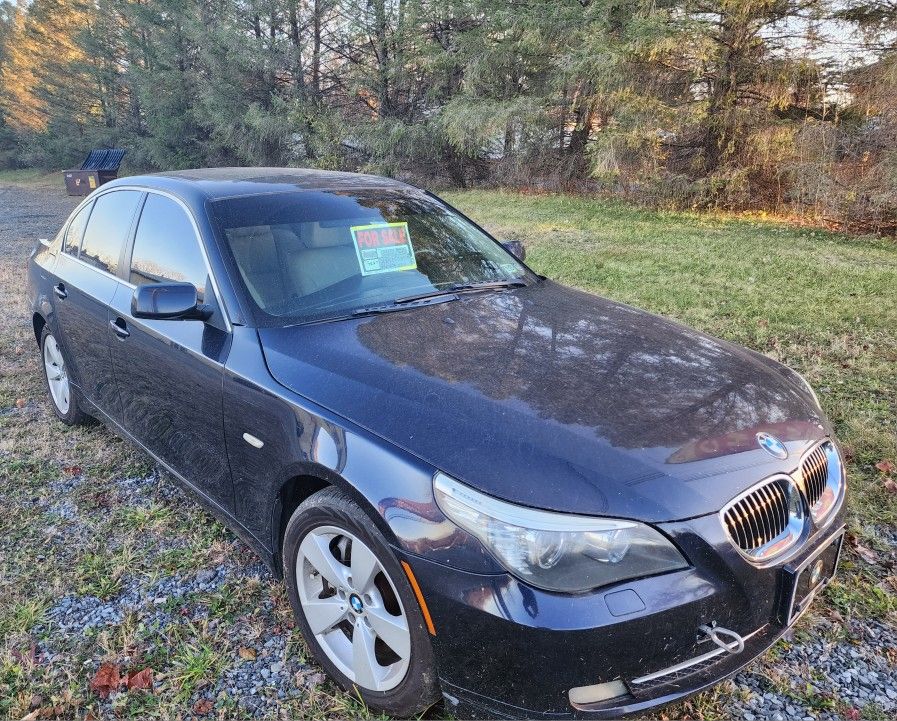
[{"xmin": 212, "ymin": 190, "xmax": 531, "ymax": 325}]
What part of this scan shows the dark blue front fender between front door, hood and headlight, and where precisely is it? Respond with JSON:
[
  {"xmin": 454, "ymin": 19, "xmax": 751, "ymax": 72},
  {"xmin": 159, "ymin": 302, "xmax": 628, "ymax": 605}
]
[{"xmin": 224, "ymin": 327, "xmax": 501, "ymax": 573}]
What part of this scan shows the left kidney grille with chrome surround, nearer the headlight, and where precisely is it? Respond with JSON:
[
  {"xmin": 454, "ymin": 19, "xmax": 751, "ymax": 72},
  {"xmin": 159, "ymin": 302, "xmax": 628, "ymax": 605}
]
[{"xmin": 720, "ymin": 473, "xmax": 806, "ymax": 563}]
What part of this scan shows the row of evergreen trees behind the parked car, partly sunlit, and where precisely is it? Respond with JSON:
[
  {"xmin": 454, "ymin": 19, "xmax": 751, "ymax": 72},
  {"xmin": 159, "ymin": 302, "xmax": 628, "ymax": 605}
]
[{"xmin": 0, "ymin": 0, "xmax": 897, "ymax": 232}]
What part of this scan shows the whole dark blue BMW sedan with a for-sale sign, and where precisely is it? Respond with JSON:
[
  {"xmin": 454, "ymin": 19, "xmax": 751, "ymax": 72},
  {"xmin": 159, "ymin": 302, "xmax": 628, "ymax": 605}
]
[{"xmin": 28, "ymin": 168, "xmax": 846, "ymax": 718}]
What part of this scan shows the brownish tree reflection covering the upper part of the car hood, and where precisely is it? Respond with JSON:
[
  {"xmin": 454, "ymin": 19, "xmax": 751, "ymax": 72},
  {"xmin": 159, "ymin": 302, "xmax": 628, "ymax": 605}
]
[{"xmin": 358, "ymin": 284, "xmax": 820, "ymax": 452}]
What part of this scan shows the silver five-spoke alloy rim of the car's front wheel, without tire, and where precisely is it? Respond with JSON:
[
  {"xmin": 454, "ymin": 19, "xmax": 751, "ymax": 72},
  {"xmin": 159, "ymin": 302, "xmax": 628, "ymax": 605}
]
[{"xmin": 296, "ymin": 526, "xmax": 411, "ymax": 692}]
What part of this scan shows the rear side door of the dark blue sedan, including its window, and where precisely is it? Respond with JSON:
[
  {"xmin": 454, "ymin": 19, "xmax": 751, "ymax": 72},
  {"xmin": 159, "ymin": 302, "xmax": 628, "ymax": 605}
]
[{"xmin": 51, "ymin": 190, "xmax": 143, "ymax": 420}]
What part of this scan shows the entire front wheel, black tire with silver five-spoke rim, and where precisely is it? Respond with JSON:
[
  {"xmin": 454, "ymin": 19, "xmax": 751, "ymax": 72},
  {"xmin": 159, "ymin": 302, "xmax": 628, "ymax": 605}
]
[{"xmin": 283, "ymin": 488, "xmax": 439, "ymax": 716}]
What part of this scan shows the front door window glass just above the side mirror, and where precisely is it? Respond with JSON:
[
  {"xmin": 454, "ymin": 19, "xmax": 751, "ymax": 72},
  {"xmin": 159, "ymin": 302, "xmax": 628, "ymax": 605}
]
[{"xmin": 130, "ymin": 193, "xmax": 208, "ymax": 303}]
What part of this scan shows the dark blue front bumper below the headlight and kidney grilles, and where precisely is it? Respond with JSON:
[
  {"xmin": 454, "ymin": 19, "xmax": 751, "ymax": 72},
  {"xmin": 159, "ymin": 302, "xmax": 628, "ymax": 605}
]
[{"xmin": 407, "ymin": 511, "xmax": 843, "ymax": 718}]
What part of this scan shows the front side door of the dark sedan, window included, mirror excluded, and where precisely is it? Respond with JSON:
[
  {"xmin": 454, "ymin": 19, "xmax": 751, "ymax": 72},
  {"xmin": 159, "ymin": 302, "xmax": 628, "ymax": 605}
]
[{"xmin": 109, "ymin": 192, "xmax": 233, "ymax": 511}]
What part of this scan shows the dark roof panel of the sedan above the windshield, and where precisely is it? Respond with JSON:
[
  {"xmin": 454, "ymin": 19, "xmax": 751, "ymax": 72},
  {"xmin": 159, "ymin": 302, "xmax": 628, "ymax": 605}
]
[{"xmin": 103, "ymin": 168, "xmax": 420, "ymax": 201}]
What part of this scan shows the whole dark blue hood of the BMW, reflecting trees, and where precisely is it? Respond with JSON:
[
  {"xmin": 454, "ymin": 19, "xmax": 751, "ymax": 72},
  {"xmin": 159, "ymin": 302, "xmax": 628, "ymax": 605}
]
[{"xmin": 259, "ymin": 280, "xmax": 828, "ymax": 522}]
